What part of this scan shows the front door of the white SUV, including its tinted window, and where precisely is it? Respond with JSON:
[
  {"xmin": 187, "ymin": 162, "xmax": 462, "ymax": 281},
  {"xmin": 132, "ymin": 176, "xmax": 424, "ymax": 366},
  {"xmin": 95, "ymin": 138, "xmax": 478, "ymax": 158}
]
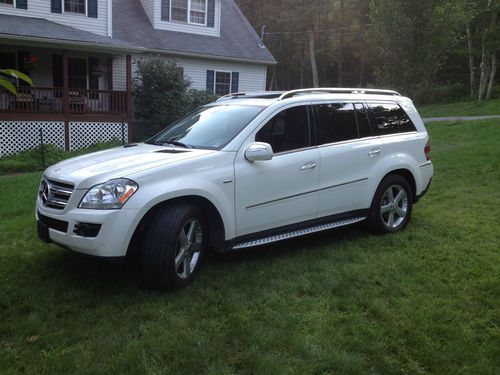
[{"xmin": 234, "ymin": 106, "xmax": 320, "ymax": 236}]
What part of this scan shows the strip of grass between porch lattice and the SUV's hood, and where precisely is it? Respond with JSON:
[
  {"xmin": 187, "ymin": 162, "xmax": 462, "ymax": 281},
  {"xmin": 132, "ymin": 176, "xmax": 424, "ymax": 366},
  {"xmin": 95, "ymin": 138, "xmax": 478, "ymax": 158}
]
[{"xmin": 0, "ymin": 140, "xmax": 121, "ymax": 176}]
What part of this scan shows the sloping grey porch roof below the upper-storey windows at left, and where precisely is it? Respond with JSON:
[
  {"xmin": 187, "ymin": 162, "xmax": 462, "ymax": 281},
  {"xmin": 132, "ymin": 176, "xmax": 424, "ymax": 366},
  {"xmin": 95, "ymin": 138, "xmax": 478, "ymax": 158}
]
[{"xmin": 0, "ymin": 14, "xmax": 143, "ymax": 51}]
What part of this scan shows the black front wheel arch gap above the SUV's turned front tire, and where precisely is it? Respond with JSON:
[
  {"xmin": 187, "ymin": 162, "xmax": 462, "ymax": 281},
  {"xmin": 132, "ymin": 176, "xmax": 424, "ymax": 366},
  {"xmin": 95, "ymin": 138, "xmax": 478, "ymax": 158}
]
[{"xmin": 127, "ymin": 195, "xmax": 225, "ymax": 255}]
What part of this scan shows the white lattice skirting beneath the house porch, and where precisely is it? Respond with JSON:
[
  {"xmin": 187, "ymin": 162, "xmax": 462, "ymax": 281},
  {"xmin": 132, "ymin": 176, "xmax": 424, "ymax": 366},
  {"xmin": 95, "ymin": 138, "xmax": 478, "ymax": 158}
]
[{"xmin": 0, "ymin": 121, "xmax": 128, "ymax": 157}]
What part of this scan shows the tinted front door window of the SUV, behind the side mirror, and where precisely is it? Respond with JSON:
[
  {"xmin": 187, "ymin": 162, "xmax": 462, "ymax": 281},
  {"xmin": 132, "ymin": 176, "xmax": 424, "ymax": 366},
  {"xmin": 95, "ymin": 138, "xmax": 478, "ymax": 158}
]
[{"xmin": 255, "ymin": 106, "xmax": 311, "ymax": 153}]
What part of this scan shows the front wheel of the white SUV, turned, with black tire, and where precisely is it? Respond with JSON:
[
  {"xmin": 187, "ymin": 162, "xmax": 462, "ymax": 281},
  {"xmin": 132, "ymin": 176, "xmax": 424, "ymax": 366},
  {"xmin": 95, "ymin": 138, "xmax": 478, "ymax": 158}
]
[{"xmin": 141, "ymin": 203, "xmax": 208, "ymax": 290}]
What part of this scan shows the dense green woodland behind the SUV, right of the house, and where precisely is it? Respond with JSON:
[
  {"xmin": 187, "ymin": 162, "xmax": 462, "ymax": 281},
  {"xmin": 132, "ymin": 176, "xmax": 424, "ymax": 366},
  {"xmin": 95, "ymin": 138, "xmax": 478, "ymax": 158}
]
[{"xmin": 237, "ymin": 0, "xmax": 500, "ymax": 103}]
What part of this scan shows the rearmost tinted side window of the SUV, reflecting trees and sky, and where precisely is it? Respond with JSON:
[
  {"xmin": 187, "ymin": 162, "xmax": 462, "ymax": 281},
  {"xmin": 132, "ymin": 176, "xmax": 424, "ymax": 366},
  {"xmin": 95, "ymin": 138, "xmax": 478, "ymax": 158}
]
[{"xmin": 368, "ymin": 103, "xmax": 416, "ymax": 135}]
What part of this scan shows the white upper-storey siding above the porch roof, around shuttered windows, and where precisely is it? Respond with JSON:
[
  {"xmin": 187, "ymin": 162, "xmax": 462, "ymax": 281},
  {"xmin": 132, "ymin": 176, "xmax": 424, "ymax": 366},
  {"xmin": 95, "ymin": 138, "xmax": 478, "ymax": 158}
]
[{"xmin": 0, "ymin": 0, "xmax": 111, "ymax": 36}]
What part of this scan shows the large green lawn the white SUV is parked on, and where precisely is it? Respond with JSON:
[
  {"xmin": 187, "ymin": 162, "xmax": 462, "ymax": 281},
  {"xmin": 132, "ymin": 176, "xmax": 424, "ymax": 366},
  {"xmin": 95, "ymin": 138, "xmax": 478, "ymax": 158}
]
[{"xmin": 0, "ymin": 120, "xmax": 500, "ymax": 374}]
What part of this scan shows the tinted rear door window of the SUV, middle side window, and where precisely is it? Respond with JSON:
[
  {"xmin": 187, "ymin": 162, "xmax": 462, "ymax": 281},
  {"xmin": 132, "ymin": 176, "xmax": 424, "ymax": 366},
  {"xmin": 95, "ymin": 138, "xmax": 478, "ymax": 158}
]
[{"xmin": 315, "ymin": 103, "xmax": 358, "ymax": 145}]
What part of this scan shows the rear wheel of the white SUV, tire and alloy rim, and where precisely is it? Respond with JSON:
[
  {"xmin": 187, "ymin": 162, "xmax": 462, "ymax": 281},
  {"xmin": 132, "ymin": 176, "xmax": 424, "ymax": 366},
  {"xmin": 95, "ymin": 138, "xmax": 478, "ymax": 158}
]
[{"xmin": 368, "ymin": 174, "xmax": 413, "ymax": 233}]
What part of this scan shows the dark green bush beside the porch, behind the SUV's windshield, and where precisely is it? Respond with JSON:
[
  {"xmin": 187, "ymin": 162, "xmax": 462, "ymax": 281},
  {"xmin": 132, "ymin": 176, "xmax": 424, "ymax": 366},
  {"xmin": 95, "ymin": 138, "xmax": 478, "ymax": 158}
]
[{"xmin": 134, "ymin": 58, "xmax": 217, "ymax": 140}]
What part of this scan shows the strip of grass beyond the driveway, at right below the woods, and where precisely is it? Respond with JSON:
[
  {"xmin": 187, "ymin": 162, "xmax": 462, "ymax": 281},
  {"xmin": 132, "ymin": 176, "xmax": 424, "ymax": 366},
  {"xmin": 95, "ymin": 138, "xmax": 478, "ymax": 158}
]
[{"xmin": 417, "ymin": 99, "xmax": 500, "ymax": 117}]
